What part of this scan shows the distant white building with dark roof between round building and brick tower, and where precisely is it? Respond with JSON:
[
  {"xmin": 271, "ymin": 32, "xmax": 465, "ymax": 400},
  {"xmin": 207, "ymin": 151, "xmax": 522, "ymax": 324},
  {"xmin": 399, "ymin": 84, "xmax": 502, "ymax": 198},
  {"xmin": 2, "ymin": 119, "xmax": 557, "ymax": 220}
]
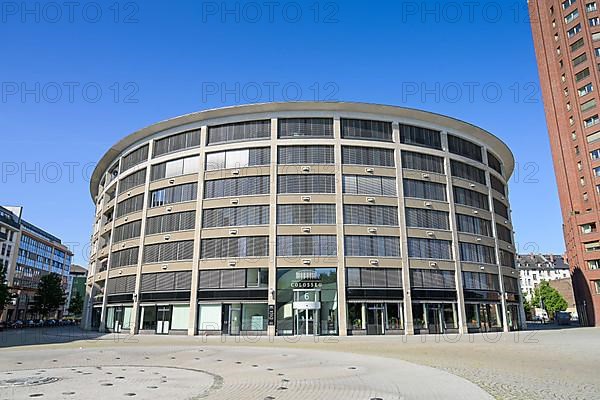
[{"xmin": 517, "ymin": 254, "xmax": 571, "ymax": 300}]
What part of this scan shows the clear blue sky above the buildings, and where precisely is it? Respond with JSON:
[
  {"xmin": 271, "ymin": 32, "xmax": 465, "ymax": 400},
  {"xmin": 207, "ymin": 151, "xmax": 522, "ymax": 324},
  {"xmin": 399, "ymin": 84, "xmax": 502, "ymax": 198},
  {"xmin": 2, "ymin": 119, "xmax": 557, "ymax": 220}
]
[{"xmin": 0, "ymin": 0, "xmax": 564, "ymax": 265}]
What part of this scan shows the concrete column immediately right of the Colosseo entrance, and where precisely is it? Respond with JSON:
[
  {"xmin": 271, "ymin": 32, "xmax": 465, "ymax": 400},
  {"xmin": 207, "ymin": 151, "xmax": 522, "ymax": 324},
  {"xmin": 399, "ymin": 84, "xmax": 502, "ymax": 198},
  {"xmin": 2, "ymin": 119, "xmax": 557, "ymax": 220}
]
[{"xmin": 333, "ymin": 115, "xmax": 348, "ymax": 336}]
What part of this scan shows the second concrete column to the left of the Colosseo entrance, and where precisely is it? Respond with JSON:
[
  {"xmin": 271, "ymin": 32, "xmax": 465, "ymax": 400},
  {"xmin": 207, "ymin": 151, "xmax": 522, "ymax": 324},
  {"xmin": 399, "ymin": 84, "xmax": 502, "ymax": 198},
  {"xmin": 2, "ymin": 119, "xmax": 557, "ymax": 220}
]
[{"xmin": 188, "ymin": 126, "xmax": 208, "ymax": 336}]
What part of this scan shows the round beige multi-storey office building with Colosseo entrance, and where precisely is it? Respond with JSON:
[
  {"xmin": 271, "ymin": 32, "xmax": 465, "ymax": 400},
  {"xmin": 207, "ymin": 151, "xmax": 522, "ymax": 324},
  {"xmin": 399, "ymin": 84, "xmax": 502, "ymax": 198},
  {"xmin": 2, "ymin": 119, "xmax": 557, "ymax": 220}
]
[{"xmin": 86, "ymin": 102, "xmax": 523, "ymax": 335}]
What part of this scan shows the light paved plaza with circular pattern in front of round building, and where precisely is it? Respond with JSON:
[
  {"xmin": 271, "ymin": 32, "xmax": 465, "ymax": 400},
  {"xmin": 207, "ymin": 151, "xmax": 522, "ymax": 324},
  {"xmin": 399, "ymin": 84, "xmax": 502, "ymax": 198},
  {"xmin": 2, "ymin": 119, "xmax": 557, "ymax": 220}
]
[{"xmin": 0, "ymin": 328, "xmax": 600, "ymax": 400}]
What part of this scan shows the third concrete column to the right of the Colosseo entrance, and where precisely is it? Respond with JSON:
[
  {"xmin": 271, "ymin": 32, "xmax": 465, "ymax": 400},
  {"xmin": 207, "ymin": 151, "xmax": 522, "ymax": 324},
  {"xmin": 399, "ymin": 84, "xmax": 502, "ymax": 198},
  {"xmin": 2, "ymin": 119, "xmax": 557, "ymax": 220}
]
[{"xmin": 442, "ymin": 131, "xmax": 469, "ymax": 334}]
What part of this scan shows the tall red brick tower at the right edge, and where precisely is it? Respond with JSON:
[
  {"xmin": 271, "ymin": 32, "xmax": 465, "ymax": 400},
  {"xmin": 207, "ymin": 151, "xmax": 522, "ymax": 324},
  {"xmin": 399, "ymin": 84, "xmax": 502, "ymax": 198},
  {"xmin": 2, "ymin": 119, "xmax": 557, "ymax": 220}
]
[{"xmin": 529, "ymin": 0, "xmax": 600, "ymax": 325}]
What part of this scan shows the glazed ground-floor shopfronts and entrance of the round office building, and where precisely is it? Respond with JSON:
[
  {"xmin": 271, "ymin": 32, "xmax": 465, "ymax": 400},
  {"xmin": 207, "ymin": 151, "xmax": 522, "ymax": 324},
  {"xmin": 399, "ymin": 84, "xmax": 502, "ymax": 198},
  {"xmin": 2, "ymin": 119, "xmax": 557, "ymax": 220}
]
[{"xmin": 92, "ymin": 268, "xmax": 521, "ymax": 336}]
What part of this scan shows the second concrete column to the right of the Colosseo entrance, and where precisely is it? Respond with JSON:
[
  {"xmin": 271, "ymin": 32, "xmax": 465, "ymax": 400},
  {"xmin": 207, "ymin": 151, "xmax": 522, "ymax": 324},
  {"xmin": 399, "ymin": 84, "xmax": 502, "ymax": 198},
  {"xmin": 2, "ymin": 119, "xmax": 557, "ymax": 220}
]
[{"xmin": 392, "ymin": 122, "xmax": 415, "ymax": 335}]
